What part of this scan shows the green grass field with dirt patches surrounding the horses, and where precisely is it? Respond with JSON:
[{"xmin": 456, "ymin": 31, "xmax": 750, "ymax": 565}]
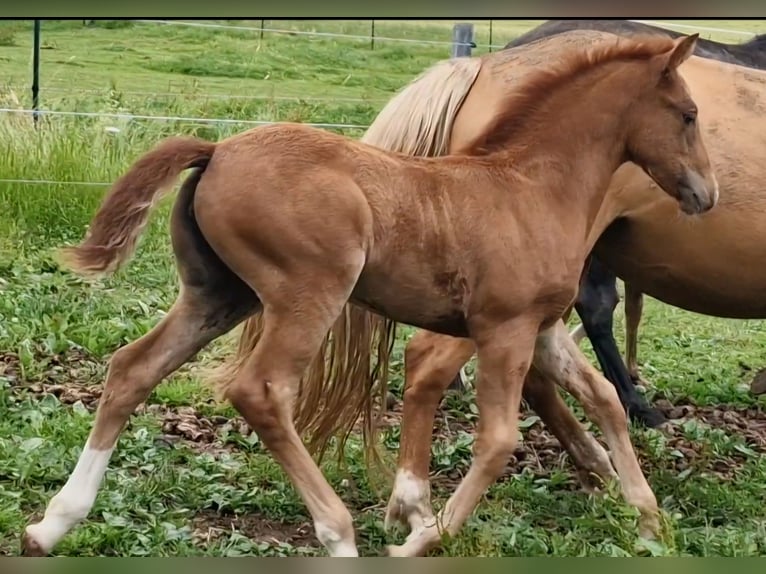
[{"xmin": 0, "ymin": 20, "xmax": 766, "ymax": 556}]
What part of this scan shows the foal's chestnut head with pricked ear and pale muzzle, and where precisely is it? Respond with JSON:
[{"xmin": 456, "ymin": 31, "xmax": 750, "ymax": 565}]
[{"xmin": 624, "ymin": 34, "xmax": 718, "ymax": 218}]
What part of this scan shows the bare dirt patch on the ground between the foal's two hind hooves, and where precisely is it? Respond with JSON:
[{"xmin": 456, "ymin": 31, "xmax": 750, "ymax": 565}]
[{"xmin": 192, "ymin": 510, "xmax": 319, "ymax": 548}]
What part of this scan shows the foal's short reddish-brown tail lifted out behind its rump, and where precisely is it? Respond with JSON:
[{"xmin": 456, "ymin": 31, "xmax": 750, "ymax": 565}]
[{"xmin": 60, "ymin": 137, "xmax": 216, "ymax": 275}]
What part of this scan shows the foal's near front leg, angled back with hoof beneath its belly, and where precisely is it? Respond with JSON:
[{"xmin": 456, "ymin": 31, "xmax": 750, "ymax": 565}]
[{"xmin": 389, "ymin": 317, "xmax": 537, "ymax": 556}]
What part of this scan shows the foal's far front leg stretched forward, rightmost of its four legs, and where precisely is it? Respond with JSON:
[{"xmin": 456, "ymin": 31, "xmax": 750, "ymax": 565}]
[{"xmin": 534, "ymin": 321, "xmax": 659, "ymax": 538}]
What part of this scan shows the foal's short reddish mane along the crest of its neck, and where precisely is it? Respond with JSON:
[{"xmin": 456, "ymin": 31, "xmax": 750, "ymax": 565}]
[{"xmin": 463, "ymin": 35, "xmax": 673, "ymax": 155}]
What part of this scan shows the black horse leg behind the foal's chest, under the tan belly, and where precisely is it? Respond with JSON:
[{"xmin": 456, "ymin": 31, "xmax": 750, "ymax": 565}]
[{"xmin": 575, "ymin": 257, "xmax": 666, "ymax": 427}]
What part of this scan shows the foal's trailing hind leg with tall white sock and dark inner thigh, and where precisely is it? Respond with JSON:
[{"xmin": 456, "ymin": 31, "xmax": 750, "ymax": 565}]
[{"xmin": 22, "ymin": 174, "xmax": 258, "ymax": 555}]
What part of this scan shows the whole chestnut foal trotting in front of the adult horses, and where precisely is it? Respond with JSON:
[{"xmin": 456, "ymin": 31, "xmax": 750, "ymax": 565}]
[{"xmin": 23, "ymin": 32, "xmax": 718, "ymax": 556}]
